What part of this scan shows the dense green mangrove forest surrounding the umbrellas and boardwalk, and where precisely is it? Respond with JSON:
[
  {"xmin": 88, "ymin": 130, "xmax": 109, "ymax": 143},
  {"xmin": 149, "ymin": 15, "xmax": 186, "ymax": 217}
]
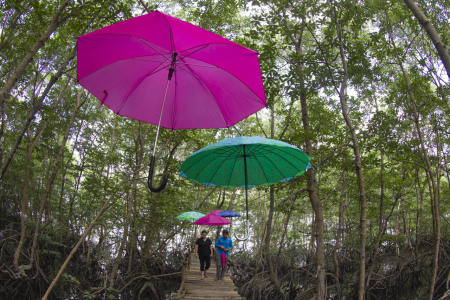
[{"xmin": 0, "ymin": 0, "xmax": 450, "ymax": 300}]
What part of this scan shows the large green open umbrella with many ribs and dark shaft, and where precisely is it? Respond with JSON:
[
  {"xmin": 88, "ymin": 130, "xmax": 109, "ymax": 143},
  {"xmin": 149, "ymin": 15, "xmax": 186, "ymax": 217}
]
[{"xmin": 179, "ymin": 136, "xmax": 311, "ymax": 239}]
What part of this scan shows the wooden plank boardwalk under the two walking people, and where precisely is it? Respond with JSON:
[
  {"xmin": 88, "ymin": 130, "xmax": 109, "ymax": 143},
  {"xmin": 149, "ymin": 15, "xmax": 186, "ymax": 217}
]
[{"xmin": 173, "ymin": 254, "xmax": 246, "ymax": 300}]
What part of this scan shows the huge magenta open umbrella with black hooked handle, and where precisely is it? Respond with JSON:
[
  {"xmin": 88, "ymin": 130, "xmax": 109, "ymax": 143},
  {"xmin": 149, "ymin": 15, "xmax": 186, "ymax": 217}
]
[{"xmin": 77, "ymin": 11, "xmax": 266, "ymax": 192}]
